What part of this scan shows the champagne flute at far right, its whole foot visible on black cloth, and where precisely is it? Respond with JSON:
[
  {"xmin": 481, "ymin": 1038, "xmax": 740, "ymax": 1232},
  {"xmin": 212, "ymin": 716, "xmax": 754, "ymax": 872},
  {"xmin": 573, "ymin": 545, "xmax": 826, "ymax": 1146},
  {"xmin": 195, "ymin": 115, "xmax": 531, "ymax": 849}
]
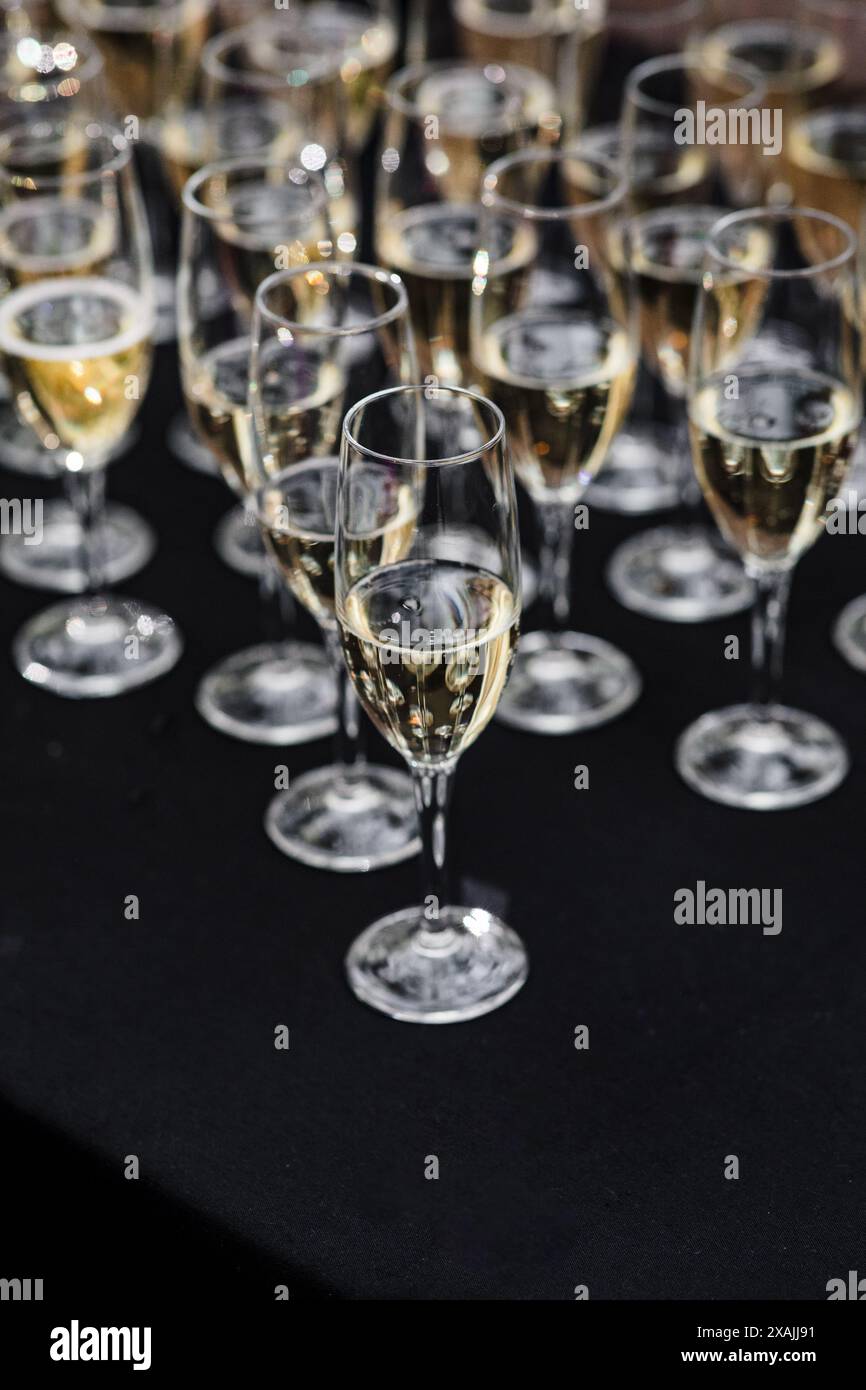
[{"xmin": 676, "ymin": 207, "xmax": 863, "ymax": 810}]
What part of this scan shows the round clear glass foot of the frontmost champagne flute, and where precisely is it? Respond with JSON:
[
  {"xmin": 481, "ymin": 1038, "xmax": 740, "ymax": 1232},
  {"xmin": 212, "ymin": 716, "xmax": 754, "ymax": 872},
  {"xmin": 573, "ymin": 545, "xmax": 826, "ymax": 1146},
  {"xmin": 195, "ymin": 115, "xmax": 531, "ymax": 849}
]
[{"xmin": 346, "ymin": 908, "xmax": 530, "ymax": 1023}]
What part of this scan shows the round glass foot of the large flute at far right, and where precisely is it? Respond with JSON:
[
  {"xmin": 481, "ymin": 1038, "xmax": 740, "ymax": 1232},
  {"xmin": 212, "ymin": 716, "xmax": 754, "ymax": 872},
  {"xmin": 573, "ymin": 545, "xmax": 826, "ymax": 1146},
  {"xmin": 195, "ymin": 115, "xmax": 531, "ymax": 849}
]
[{"xmin": 674, "ymin": 705, "xmax": 849, "ymax": 810}]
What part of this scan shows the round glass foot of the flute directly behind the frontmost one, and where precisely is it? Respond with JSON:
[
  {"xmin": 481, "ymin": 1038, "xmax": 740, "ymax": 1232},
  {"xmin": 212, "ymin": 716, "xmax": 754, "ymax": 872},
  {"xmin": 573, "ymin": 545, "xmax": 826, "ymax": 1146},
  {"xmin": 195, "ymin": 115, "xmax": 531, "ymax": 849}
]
[{"xmin": 264, "ymin": 763, "xmax": 421, "ymax": 873}]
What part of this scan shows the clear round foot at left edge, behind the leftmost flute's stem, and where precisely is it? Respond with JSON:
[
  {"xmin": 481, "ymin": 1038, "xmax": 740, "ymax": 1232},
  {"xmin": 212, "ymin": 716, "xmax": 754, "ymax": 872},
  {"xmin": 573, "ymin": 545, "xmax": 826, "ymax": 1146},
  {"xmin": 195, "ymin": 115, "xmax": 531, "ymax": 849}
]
[{"xmin": 0, "ymin": 502, "xmax": 156, "ymax": 594}]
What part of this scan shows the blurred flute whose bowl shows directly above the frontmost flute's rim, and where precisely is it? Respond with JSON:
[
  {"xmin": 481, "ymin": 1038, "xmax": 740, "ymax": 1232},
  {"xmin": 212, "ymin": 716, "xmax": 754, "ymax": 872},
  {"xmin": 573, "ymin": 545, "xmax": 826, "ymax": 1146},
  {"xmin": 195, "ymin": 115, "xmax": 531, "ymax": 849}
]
[{"xmin": 375, "ymin": 63, "xmax": 560, "ymax": 385}]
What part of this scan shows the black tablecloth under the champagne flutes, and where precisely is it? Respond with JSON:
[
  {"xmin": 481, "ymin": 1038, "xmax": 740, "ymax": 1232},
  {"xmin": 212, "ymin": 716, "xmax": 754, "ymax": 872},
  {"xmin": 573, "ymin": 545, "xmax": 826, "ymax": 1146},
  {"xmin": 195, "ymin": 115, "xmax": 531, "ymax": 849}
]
[{"xmin": 0, "ymin": 336, "xmax": 866, "ymax": 1300}]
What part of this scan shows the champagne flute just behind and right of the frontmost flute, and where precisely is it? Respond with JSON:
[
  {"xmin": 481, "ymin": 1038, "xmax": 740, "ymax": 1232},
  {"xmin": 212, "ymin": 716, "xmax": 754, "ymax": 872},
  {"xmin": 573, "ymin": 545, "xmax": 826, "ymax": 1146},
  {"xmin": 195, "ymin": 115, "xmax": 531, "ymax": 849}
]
[{"xmin": 471, "ymin": 146, "xmax": 641, "ymax": 734}]
